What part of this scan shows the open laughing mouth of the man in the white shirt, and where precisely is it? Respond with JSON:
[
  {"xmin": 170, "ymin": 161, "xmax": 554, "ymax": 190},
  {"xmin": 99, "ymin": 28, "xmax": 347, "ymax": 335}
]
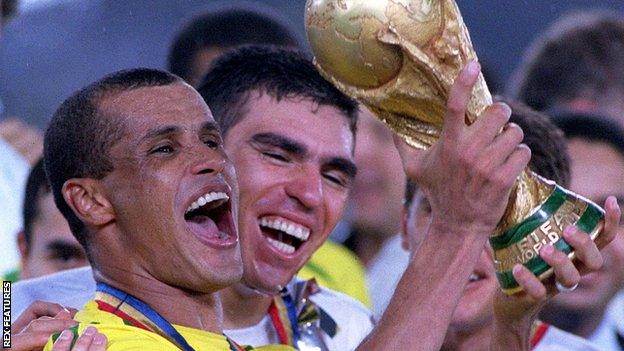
[{"xmin": 258, "ymin": 216, "xmax": 310, "ymax": 254}]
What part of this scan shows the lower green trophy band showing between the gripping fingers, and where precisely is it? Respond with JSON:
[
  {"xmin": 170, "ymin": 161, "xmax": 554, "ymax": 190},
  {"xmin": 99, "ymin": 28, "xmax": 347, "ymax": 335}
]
[{"xmin": 496, "ymin": 203, "xmax": 604, "ymax": 290}]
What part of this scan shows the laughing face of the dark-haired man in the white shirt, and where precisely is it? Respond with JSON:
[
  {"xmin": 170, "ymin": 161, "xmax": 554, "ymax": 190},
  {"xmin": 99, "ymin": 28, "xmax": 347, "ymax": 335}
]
[{"xmin": 225, "ymin": 92, "xmax": 355, "ymax": 293}]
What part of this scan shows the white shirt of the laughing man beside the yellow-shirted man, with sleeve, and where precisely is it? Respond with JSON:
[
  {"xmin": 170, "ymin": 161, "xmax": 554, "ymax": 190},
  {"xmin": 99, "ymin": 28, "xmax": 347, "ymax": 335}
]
[{"xmin": 11, "ymin": 267, "xmax": 373, "ymax": 351}]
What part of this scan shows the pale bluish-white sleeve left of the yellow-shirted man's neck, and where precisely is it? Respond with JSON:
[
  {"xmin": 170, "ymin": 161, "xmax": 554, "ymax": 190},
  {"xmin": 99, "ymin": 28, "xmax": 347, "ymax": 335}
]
[{"xmin": 11, "ymin": 267, "xmax": 95, "ymax": 318}]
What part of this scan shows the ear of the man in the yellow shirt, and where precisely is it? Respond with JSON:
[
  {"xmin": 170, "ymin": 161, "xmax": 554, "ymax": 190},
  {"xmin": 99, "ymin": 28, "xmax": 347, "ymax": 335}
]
[{"xmin": 62, "ymin": 178, "xmax": 115, "ymax": 226}]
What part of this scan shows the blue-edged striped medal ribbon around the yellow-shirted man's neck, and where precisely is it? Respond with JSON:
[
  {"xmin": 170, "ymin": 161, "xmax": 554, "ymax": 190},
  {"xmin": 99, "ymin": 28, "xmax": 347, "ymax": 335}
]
[{"xmin": 95, "ymin": 283, "xmax": 245, "ymax": 351}]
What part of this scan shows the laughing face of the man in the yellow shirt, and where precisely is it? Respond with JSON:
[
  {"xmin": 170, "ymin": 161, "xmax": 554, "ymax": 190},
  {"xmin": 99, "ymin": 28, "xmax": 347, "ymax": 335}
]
[{"xmin": 92, "ymin": 83, "xmax": 242, "ymax": 293}]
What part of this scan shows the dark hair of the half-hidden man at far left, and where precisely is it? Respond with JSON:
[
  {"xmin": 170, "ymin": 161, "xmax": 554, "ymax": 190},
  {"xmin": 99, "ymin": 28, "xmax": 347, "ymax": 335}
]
[{"xmin": 22, "ymin": 159, "xmax": 50, "ymax": 247}]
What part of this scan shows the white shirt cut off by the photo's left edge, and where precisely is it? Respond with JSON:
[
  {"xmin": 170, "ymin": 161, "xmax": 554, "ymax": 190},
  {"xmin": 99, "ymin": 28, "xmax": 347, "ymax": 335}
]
[{"xmin": 0, "ymin": 139, "xmax": 30, "ymax": 275}]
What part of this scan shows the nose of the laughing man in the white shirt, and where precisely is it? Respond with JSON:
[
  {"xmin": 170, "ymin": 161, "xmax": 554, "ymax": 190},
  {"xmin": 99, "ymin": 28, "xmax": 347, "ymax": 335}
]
[{"xmin": 285, "ymin": 167, "xmax": 323, "ymax": 210}]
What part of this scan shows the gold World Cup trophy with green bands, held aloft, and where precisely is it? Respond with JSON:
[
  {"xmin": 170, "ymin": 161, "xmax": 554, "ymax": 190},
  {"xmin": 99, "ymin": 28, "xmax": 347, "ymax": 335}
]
[{"xmin": 305, "ymin": 0, "xmax": 604, "ymax": 294}]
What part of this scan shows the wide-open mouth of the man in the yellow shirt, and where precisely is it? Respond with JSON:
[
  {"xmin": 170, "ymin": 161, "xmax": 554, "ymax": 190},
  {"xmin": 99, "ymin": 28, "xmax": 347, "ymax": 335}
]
[{"xmin": 184, "ymin": 191, "xmax": 237, "ymax": 248}]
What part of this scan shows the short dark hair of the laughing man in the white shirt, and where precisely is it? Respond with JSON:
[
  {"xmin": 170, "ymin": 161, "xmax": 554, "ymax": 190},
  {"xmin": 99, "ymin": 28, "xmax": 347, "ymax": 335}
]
[{"xmin": 198, "ymin": 45, "xmax": 358, "ymax": 138}]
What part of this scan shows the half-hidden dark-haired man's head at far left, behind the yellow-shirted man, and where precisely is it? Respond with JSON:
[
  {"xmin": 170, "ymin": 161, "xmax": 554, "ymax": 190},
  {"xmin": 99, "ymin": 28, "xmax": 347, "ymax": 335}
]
[{"xmin": 14, "ymin": 160, "xmax": 89, "ymax": 280}]
